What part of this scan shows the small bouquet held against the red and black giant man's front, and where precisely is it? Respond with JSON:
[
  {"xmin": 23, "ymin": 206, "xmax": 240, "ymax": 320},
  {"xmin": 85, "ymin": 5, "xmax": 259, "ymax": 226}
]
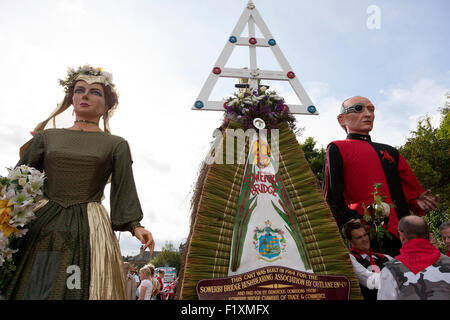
[{"xmin": 363, "ymin": 183, "xmax": 395, "ymax": 241}]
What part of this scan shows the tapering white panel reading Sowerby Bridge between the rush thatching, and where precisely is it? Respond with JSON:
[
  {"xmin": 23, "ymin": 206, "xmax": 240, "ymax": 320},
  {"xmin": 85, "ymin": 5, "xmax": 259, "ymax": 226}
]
[{"xmin": 228, "ymin": 131, "xmax": 313, "ymax": 276}]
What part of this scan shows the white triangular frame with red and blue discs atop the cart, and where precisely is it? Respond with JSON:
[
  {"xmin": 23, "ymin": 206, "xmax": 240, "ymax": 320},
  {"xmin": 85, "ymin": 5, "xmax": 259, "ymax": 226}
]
[{"xmin": 192, "ymin": 0, "xmax": 319, "ymax": 115}]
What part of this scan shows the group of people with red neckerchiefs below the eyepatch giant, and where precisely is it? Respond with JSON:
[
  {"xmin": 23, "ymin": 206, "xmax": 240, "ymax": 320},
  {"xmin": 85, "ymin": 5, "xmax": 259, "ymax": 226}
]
[{"xmin": 342, "ymin": 215, "xmax": 450, "ymax": 300}]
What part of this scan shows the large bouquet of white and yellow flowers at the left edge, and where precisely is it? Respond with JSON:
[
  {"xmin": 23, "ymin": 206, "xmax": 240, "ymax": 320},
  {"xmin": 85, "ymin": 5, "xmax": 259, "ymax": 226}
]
[{"xmin": 0, "ymin": 165, "xmax": 45, "ymax": 292}]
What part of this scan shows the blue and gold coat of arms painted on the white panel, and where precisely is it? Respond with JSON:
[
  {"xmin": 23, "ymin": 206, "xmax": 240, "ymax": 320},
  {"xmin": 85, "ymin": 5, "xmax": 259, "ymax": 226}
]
[{"xmin": 253, "ymin": 220, "xmax": 286, "ymax": 262}]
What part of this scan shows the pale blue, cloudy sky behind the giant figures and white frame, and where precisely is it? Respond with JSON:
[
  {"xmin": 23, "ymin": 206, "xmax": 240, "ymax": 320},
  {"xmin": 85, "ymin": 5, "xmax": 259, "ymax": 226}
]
[{"xmin": 0, "ymin": 0, "xmax": 450, "ymax": 254}]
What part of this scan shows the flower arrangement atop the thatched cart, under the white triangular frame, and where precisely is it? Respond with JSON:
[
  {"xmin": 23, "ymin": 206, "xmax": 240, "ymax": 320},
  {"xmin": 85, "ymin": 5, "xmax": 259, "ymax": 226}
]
[{"xmin": 224, "ymin": 86, "xmax": 295, "ymax": 129}]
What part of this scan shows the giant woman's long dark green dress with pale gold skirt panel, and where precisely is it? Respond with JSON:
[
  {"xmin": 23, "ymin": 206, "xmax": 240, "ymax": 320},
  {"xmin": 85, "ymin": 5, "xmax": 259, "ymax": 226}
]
[{"xmin": 6, "ymin": 129, "xmax": 143, "ymax": 299}]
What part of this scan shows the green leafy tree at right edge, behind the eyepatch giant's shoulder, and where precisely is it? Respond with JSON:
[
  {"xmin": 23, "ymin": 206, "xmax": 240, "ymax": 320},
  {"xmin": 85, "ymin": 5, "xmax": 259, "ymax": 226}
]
[{"xmin": 399, "ymin": 92, "xmax": 450, "ymax": 246}]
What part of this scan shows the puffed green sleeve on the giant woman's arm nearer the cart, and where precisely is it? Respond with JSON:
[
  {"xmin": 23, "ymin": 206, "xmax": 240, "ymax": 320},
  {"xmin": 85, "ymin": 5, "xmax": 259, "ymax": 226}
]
[{"xmin": 110, "ymin": 140, "xmax": 143, "ymax": 235}]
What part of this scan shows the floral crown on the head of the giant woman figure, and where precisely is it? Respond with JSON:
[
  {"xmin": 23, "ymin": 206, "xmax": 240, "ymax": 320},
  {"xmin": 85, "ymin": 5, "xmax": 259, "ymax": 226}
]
[{"xmin": 59, "ymin": 64, "xmax": 114, "ymax": 93}]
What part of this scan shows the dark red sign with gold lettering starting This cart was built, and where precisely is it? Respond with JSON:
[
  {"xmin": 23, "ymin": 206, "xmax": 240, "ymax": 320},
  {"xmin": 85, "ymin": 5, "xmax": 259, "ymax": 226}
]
[{"xmin": 197, "ymin": 266, "xmax": 350, "ymax": 300}]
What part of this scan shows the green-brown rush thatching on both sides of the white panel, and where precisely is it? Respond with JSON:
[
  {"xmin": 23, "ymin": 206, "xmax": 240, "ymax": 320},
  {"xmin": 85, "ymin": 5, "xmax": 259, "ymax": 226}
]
[{"xmin": 177, "ymin": 122, "xmax": 362, "ymax": 299}]
